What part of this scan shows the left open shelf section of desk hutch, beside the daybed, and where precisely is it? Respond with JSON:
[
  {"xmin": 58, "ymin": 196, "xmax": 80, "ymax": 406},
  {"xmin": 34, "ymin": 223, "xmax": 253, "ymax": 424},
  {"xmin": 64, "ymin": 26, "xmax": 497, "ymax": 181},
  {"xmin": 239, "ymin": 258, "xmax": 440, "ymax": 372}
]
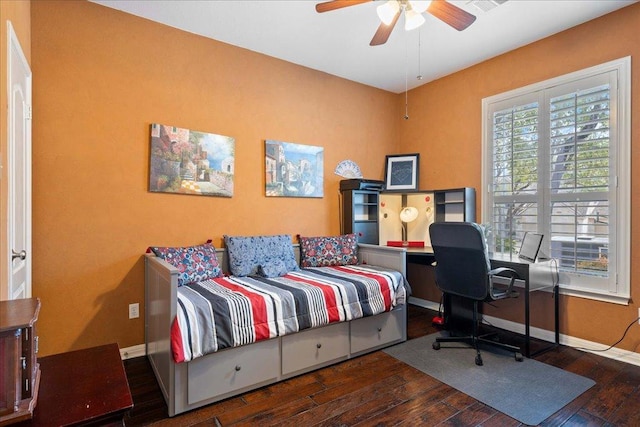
[{"xmin": 341, "ymin": 190, "xmax": 380, "ymax": 245}]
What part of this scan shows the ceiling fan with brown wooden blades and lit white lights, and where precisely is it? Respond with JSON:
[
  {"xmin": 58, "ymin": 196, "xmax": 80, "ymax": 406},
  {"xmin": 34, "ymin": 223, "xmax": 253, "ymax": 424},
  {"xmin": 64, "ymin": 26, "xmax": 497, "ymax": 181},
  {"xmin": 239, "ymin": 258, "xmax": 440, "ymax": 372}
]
[{"xmin": 316, "ymin": 0, "xmax": 476, "ymax": 46}]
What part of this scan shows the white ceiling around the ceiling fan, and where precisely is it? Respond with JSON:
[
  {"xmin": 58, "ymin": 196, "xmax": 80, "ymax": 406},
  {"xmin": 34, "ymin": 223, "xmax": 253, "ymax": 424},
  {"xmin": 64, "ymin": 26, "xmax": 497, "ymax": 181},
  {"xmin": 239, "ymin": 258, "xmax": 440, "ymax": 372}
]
[{"xmin": 91, "ymin": 0, "xmax": 638, "ymax": 93}]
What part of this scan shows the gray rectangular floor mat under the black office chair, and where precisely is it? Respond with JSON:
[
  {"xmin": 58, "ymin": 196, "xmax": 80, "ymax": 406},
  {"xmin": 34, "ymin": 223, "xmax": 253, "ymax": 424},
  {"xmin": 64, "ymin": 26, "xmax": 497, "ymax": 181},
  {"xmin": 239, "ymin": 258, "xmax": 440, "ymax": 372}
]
[{"xmin": 384, "ymin": 333, "xmax": 595, "ymax": 425}]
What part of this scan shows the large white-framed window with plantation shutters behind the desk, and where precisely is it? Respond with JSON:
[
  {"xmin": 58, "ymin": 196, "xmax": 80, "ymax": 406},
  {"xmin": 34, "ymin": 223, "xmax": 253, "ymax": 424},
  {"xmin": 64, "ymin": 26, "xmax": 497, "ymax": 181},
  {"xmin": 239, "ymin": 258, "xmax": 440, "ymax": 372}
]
[{"xmin": 482, "ymin": 57, "xmax": 631, "ymax": 304}]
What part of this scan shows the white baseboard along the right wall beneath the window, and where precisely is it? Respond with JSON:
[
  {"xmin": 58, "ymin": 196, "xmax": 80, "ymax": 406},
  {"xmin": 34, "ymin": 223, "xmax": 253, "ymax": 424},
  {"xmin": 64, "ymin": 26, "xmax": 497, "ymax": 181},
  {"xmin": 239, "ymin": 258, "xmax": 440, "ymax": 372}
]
[{"xmin": 409, "ymin": 297, "xmax": 640, "ymax": 366}]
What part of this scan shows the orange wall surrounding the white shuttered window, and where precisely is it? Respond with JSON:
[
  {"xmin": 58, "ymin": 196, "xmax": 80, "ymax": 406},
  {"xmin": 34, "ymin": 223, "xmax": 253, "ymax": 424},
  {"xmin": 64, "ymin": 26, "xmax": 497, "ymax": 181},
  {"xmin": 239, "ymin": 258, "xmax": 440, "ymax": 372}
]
[{"xmin": 398, "ymin": 4, "xmax": 640, "ymax": 351}]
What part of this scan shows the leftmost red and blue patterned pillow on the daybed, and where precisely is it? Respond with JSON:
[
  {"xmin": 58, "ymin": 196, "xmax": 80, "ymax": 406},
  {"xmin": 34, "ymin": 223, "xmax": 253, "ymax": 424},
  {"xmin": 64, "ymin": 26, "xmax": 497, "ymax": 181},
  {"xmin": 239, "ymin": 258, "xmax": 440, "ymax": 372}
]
[{"xmin": 151, "ymin": 243, "xmax": 222, "ymax": 286}]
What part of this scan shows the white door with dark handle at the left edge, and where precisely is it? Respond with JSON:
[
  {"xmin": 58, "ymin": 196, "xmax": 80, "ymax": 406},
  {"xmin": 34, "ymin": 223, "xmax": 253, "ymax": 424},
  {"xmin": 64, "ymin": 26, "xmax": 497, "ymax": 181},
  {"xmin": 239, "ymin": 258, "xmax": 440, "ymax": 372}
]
[{"xmin": 6, "ymin": 21, "xmax": 32, "ymax": 299}]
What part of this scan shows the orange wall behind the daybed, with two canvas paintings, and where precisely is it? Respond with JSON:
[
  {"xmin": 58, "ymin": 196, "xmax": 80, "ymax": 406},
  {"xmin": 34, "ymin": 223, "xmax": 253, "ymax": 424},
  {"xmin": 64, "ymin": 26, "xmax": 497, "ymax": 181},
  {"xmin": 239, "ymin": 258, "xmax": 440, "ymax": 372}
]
[{"xmin": 31, "ymin": 1, "xmax": 398, "ymax": 355}]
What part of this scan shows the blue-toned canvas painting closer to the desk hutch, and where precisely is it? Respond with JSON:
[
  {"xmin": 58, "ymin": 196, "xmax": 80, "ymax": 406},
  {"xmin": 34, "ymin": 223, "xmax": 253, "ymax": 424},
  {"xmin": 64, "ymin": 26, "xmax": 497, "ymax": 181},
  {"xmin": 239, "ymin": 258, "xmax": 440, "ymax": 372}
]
[{"xmin": 265, "ymin": 140, "xmax": 324, "ymax": 197}]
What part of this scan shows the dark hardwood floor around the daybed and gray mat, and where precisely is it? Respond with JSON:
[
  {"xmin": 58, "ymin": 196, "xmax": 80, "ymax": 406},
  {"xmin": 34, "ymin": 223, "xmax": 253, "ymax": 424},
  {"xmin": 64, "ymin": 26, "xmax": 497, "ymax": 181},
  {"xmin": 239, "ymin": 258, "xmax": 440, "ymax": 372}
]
[{"xmin": 124, "ymin": 306, "xmax": 640, "ymax": 427}]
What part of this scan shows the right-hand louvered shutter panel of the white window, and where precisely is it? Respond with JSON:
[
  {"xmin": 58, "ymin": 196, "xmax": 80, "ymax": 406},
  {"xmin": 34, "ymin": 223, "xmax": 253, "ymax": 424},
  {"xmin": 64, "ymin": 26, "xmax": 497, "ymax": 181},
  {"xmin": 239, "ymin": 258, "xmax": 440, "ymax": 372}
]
[{"xmin": 548, "ymin": 81, "xmax": 616, "ymax": 284}]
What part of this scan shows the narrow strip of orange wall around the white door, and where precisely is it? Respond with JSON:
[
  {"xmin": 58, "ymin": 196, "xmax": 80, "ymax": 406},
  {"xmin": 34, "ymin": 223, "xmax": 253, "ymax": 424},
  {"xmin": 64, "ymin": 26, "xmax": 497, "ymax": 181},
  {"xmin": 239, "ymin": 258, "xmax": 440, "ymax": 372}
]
[{"xmin": 0, "ymin": 0, "xmax": 31, "ymax": 300}]
